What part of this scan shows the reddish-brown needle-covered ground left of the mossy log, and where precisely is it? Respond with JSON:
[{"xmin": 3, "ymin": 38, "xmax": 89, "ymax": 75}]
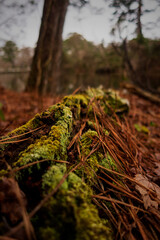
[{"xmin": 0, "ymin": 87, "xmax": 62, "ymax": 136}]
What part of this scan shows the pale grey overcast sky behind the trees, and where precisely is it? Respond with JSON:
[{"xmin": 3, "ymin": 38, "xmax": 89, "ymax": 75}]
[{"xmin": 0, "ymin": 0, "xmax": 160, "ymax": 47}]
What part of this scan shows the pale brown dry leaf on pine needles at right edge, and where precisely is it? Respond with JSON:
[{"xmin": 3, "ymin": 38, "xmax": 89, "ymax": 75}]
[{"xmin": 134, "ymin": 174, "xmax": 160, "ymax": 209}]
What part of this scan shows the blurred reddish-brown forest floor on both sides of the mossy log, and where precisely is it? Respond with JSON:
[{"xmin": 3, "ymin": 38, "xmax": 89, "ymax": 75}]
[{"xmin": 0, "ymin": 87, "xmax": 160, "ymax": 161}]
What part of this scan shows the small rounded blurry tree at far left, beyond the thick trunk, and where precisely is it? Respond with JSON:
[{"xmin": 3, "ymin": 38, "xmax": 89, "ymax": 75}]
[{"xmin": 2, "ymin": 41, "xmax": 18, "ymax": 67}]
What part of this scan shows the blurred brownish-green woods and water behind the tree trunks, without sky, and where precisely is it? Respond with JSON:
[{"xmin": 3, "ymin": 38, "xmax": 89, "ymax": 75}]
[{"xmin": 0, "ymin": 33, "xmax": 160, "ymax": 94}]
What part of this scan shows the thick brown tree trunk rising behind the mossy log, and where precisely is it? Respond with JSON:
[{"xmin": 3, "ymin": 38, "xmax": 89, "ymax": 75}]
[{"xmin": 26, "ymin": 0, "xmax": 69, "ymax": 94}]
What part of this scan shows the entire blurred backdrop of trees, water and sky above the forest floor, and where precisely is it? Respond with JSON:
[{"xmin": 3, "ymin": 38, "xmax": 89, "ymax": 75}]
[{"xmin": 0, "ymin": 0, "xmax": 160, "ymax": 95}]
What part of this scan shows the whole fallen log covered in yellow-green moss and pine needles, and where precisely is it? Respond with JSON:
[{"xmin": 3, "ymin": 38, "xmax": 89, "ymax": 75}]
[{"xmin": 0, "ymin": 89, "xmax": 128, "ymax": 240}]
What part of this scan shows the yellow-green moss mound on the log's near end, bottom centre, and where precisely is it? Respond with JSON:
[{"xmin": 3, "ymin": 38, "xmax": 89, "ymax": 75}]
[{"xmin": 35, "ymin": 164, "xmax": 113, "ymax": 240}]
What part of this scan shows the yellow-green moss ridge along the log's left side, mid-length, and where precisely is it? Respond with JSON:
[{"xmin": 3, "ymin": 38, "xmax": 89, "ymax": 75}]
[{"xmin": 14, "ymin": 105, "xmax": 72, "ymax": 172}]
